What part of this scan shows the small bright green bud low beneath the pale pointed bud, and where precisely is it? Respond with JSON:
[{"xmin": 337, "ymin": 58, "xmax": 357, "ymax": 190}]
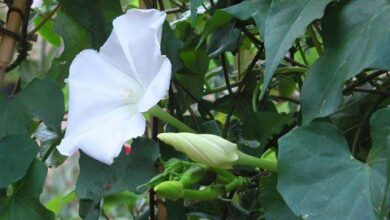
[{"xmin": 154, "ymin": 180, "xmax": 184, "ymax": 200}]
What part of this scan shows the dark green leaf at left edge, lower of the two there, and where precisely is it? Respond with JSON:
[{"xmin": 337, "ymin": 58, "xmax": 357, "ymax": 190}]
[{"xmin": 0, "ymin": 135, "xmax": 38, "ymax": 189}]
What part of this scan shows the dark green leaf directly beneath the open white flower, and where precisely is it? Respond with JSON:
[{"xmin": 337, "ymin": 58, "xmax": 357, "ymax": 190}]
[{"xmin": 76, "ymin": 138, "xmax": 159, "ymax": 201}]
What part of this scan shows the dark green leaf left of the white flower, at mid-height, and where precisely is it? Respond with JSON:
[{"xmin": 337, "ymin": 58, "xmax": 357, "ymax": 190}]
[{"xmin": 0, "ymin": 78, "xmax": 65, "ymax": 137}]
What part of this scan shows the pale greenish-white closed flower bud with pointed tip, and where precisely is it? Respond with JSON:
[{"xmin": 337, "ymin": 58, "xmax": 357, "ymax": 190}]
[{"xmin": 157, "ymin": 133, "xmax": 239, "ymax": 168}]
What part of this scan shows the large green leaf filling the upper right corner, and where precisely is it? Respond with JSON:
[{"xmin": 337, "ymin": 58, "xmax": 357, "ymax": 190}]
[{"xmin": 301, "ymin": 0, "xmax": 390, "ymax": 124}]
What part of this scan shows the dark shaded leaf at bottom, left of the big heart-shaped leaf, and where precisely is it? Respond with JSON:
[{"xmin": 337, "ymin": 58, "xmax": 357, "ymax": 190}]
[{"xmin": 259, "ymin": 174, "xmax": 300, "ymax": 220}]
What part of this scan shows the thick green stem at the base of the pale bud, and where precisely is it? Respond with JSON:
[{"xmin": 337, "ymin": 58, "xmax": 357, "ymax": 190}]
[{"xmin": 236, "ymin": 151, "xmax": 278, "ymax": 173}]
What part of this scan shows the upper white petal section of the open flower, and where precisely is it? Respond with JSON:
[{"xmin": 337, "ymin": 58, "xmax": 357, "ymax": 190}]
[{"xmin": 109, "ymin": 9, "xmax": 166, "ymax": 88}]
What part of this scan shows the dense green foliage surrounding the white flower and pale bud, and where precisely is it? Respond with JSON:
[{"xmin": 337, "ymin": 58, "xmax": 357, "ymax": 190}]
[{"xmin": 0, "ymin": 0, "xmax": 390, "ymax": 220}]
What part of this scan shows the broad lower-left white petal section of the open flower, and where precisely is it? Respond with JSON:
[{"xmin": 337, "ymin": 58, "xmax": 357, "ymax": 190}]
[{"xmin": 59, "ymin": 50, "xmax": 145, "ymax": 163}]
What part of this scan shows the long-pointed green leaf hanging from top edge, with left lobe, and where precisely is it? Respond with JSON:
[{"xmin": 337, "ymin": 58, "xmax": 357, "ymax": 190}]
[{"xmin": 225, "ymin": 0, "xmax": 332, "ymax": 97}]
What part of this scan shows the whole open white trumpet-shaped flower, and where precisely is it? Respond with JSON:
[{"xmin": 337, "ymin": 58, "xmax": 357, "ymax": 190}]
[{"xmin": 58, "ymin": 9, "xmax": 171, "ymax": 164}]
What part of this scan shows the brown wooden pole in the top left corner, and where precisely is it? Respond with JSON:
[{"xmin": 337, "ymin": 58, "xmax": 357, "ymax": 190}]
[{"xmin": 0, "ymin": 0, "xmax": 26, "ymax": 86}]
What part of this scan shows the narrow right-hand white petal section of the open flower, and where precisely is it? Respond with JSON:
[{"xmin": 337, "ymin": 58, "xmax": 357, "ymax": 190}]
[{"xmin": 137, "ymin": 56, "xmax": 172, "ymax": 112}]
